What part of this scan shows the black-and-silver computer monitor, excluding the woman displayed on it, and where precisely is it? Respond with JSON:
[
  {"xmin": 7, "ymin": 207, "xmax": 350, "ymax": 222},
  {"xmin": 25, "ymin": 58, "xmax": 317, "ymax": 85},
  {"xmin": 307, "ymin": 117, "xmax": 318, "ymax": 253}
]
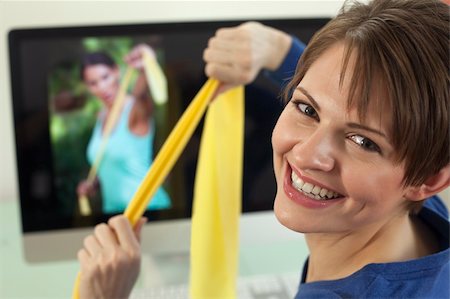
[{"xmin": 9, "ymin": 18, "xmax": 329, "ymax": 262}]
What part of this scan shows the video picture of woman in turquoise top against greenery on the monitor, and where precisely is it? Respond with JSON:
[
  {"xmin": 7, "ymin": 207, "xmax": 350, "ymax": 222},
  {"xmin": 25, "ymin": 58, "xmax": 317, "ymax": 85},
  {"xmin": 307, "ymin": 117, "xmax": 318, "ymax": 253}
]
[{"xmin": 48, "ymin": 36, "xmax": 172, "ymax": 214}]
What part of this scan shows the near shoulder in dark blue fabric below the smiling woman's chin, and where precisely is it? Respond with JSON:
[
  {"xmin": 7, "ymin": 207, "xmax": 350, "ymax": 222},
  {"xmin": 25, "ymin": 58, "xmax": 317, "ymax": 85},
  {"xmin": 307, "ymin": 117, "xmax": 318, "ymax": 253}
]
[{"xmin": 295, "ymin": 253, "xmax": 450, "ymax": 299}]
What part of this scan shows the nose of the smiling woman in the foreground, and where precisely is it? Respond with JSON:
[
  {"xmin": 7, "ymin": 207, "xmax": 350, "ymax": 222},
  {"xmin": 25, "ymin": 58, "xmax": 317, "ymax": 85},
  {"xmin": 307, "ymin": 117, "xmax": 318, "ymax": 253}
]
[{"xmin": 292, "ymin": 129, "xmax": 336, "ymax": 172}]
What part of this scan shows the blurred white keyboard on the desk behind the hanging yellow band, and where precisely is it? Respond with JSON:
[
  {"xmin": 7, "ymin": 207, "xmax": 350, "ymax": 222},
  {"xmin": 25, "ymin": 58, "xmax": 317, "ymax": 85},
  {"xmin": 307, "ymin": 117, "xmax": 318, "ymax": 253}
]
[{"xmin": 130, "ymin": 273, "xmax": 300, "ymax": 299}]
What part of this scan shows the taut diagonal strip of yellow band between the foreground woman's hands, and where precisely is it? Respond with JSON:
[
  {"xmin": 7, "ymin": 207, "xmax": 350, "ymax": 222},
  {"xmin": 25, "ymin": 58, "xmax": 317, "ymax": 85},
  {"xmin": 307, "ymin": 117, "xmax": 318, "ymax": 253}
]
[{"xmin": 72, "ymin": 79, "xmax": 223, "ymax": 299}]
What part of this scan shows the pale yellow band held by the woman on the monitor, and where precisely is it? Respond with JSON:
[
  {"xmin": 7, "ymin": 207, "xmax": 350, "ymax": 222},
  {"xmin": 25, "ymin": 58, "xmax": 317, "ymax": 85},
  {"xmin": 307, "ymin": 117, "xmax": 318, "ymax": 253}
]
[{"xmin": 78, "ymin": 51, "xmax": 168, "ymax": 216}]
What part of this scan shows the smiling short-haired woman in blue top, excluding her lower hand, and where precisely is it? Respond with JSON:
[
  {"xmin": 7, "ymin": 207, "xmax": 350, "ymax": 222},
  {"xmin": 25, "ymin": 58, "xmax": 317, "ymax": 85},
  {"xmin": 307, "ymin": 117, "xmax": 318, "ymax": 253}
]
[{"xmin": 75, "ymin": 0, "xmax": 450, "ymax": 298}]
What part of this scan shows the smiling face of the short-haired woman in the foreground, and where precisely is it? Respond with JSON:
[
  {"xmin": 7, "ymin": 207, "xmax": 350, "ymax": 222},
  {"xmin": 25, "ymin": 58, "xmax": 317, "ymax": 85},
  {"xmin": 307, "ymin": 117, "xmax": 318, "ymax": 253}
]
[{"xmin": 272, "ymin": 43, "xmax": 414, "ymax": 233}]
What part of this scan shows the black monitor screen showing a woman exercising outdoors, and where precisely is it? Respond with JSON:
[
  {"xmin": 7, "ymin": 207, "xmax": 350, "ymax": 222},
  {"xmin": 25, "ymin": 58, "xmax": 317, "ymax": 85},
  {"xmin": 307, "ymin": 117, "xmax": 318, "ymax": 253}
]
[{"xmin": 9, "ymin": 18, "xmax": 328, "ymax": 264}]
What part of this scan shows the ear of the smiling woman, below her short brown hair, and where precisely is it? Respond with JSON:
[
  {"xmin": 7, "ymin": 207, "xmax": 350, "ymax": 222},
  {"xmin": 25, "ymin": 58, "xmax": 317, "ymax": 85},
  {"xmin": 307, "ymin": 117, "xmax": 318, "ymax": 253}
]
[{"xmin": 405, "ymin": 164, "xmax": 450, "ymax": 201}]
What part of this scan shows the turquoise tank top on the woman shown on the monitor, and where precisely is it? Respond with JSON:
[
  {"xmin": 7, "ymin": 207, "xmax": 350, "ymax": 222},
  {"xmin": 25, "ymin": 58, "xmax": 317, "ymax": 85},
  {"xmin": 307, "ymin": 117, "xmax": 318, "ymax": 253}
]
[{"xmin": 87, "ymin": 99, "xmax": 171, "ymax": 214}]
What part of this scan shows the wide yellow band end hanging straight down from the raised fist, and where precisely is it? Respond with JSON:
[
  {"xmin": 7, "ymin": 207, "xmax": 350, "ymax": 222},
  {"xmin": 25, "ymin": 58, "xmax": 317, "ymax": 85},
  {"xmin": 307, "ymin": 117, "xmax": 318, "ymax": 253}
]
[{"xmin": 189, "ymin": 87, "xmax": 244, "ymax": 299}]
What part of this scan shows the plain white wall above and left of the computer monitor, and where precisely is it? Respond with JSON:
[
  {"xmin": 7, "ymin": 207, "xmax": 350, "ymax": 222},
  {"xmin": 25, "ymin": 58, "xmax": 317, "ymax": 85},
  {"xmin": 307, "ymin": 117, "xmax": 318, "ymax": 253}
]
[{"xmin": 0, "ymin": 0, "xmax": 342, "ymax": 200}]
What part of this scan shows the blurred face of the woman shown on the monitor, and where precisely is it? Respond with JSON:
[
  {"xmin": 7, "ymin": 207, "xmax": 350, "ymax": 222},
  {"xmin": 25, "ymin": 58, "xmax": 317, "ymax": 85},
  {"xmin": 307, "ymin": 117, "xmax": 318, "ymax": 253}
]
[{"xmin": 84, "ymin": 64, "xmax": 119, "ymax": 107}]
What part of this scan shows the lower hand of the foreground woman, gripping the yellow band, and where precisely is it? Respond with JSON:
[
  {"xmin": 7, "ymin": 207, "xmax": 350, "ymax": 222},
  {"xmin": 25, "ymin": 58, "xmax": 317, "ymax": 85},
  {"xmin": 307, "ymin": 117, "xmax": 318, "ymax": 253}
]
[{"xmin": 78, "ymin": 215, "xmax": 146, "ymax": 299}]
